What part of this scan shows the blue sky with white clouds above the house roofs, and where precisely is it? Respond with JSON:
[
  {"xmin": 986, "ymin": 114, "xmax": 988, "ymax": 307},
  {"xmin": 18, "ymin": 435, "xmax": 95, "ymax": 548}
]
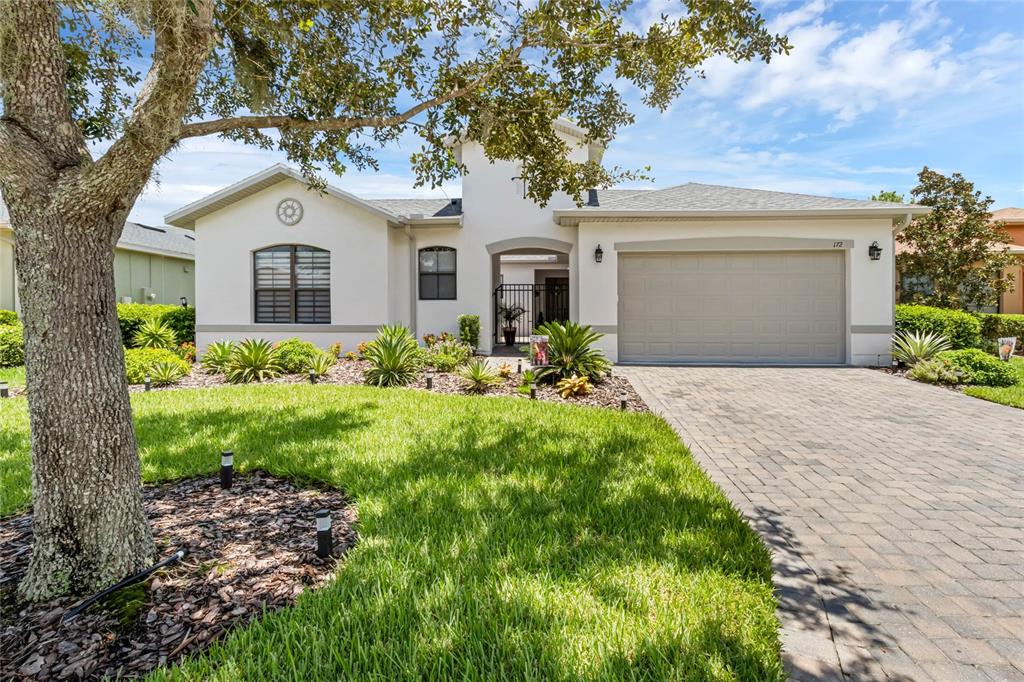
[{"xmin": 132, "ymin": 0, "xmax": 1024, "ymax": 224}]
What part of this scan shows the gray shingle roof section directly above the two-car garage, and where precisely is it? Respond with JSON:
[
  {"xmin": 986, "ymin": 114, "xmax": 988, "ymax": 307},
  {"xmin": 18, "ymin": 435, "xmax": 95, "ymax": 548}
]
[{"xmin": 584, "ymin": 182, "xmax": 925, "ymax": 211}]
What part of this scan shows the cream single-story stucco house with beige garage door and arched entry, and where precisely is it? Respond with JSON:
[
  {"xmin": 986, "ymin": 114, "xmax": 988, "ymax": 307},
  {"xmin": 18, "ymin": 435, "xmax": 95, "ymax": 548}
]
[{"xmin": 166, "ymin": 122, "xmax": 927, "ymax": 365}]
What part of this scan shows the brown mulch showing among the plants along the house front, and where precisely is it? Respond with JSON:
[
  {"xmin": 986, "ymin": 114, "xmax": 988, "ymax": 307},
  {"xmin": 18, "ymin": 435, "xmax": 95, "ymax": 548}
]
[{"xmin": 129, "ymin": 357, "xmax": 650, "ymax": 412}]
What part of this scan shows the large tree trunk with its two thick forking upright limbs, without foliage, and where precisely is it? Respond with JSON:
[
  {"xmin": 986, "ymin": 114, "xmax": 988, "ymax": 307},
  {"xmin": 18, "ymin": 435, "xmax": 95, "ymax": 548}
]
[{"xmin": 0, "ymin": 0, "xmax": 217, "ymax": 599}]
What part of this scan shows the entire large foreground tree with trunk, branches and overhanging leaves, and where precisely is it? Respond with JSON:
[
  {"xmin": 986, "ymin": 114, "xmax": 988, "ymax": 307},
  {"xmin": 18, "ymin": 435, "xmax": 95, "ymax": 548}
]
[{"xmin": 0, "ymin": 0, "xmax": 788, "ymax": 598}]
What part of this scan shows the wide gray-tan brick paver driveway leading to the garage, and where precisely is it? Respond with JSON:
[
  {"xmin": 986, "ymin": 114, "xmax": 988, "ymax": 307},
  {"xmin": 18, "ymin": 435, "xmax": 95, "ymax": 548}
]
[{"xmin": 622, "ymin": 367, "xmax": 1024, "ymax": 680}]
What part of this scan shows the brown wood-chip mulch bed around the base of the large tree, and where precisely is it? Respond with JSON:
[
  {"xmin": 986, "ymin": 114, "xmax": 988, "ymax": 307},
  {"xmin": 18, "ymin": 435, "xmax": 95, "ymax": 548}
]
[{"xmin": 0, "ymin": 472, "xmax": 355, "ymax": 680}]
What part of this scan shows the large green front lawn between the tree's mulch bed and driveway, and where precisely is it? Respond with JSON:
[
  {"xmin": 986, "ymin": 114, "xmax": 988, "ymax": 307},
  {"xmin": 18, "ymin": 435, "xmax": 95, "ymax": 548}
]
[{"xmin": 0, "ymin": 385, "xmax": 783, "ymax": 682}]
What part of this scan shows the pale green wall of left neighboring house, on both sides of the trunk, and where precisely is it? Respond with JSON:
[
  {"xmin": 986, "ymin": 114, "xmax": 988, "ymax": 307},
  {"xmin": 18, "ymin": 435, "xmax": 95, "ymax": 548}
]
[{"xmin": 0, "ymin": 231, "xmax": 196, "ymax": 310}]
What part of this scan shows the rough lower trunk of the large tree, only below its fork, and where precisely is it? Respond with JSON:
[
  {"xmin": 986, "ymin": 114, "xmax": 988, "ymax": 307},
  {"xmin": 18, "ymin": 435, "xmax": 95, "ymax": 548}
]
[{"xmin": 11, "ymin": 202, "xmax": 155, "ymax": 599}]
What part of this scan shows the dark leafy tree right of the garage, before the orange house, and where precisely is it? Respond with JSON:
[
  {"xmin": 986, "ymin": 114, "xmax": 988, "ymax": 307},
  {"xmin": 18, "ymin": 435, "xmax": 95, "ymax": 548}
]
[{"xmin": 896, "ymin": 166, "xmax": 1014, "ymax": 309}]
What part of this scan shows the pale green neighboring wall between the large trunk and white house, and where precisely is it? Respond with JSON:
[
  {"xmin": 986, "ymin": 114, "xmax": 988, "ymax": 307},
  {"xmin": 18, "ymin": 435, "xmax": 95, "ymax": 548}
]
[{"xmin": 114, "ymin": 249, "xmax": 196, "ymax": 305}]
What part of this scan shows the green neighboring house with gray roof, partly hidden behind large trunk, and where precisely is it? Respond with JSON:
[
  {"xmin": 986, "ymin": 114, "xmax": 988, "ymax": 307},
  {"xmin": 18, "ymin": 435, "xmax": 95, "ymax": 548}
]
[{"xmin": 0, "ymin": 196, "xmax": 196, "ymax": 310}]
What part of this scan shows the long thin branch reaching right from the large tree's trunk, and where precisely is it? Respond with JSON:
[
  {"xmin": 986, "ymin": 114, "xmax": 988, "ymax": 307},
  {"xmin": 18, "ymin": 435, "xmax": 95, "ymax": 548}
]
[{"xmin": 177, "ymin": 41, "xmax": 527, "ymax": 139}]
